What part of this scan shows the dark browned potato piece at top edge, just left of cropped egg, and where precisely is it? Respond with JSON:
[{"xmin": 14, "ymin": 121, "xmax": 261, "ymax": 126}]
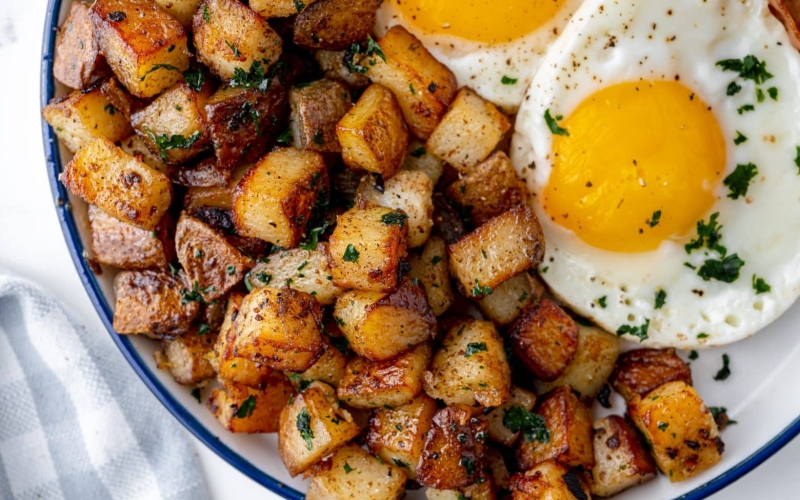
[{"xmin": 293, "ymin": 0, "xmax": 379, "ymax": 50}]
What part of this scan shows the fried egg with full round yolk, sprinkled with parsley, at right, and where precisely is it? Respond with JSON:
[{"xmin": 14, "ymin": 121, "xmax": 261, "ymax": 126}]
[{"xmin": 511, "ymin": 0, "xmax": 800, "ymax": 348}]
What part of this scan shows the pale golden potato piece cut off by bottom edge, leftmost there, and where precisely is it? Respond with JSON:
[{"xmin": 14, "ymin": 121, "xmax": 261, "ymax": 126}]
[{"xmin": 306, "ymin": 444, "xmax": 406, "ymax": 500}]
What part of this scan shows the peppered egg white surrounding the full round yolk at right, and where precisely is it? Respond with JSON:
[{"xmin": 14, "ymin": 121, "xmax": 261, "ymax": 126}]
[{"xmin": 511, "ymin": 0, "xmax": 800, "ymax": 348}]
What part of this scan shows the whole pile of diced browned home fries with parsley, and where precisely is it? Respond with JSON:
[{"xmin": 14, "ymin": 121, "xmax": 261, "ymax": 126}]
[{"xmin": 43, "ymin": 0, "xmax": 725, "ymax": 500}]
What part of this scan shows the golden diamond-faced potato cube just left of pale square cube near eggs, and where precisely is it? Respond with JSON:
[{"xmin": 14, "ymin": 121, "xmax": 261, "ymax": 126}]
[{"xmin": 336, "ymin": 84, "xmax": 408, "ymax": 179}]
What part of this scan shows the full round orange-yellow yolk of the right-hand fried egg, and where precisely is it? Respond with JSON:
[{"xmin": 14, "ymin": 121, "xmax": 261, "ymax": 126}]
[{"xmin": 544, "ymin": 81, "xmax": 725, "ymax": 252}]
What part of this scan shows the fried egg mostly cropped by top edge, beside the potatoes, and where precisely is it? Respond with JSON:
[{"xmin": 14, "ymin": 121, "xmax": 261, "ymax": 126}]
[{"xmin": 376, "ymin": 0, "xmax": 581, "ymax": 113}]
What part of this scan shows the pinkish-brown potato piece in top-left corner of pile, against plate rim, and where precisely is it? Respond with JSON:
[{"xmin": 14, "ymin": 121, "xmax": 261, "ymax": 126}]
[{"xmin": 53, "ymin": 1, "xmax": 111, "ymax": 89}]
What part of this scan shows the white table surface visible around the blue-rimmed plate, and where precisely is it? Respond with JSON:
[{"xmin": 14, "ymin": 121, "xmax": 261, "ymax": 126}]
[{"xmin": 0, "ymin": 0, "xmax": 800, "ymax": 500}]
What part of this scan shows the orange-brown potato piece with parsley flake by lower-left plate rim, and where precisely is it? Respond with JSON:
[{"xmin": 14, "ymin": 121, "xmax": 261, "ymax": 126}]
[{"xmin": 208, "ymin": 372, "xmax": 294, "ymax": 433}]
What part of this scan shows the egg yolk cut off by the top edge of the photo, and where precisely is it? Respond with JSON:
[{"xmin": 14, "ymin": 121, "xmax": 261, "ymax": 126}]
[{"xmin": 391, "ymin": 0, "xmax": 565, "ymax": 43}]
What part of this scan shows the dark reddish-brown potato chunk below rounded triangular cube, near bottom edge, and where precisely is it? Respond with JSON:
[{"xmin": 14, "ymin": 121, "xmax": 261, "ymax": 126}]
[{"xmin": 417, "ymin": 405, "xmax": 488, "ymax": 490}]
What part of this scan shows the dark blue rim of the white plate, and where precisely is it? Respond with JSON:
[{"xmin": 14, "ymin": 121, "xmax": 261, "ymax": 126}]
[{"xmin": 40, "ymin": 0, "xmax": 800, "ymax": 500}]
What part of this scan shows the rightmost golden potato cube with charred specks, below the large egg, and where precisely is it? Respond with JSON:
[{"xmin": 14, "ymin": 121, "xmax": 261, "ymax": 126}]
[{"xmin": 628, "ymin": 381, "xmax": 725, "ymax": 482}]
